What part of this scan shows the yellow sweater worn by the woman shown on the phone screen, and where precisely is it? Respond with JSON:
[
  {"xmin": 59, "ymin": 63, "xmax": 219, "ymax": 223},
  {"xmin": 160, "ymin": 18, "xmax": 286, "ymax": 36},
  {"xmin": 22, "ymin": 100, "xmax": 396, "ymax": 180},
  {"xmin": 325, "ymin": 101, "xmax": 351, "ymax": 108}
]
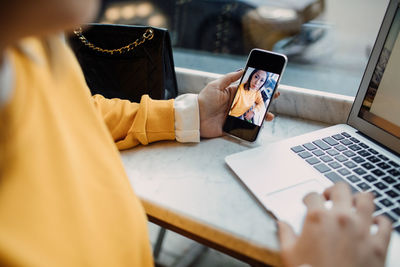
[{"xmin": 229, "ymin": 83, "xmax": 264, "ymax": 117}]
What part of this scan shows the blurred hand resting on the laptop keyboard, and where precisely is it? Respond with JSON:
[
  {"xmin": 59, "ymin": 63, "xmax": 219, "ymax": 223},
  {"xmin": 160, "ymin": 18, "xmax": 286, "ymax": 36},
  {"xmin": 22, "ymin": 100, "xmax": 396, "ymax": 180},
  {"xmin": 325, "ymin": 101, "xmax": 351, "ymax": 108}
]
[{"xmin": 279, "ymin": 183, "xmax": 392, "ymax": 267}]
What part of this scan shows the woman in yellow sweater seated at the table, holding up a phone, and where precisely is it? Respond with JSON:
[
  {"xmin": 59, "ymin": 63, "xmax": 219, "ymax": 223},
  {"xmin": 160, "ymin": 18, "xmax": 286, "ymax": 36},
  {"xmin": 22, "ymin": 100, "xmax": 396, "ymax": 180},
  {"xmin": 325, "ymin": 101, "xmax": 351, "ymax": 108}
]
[{"xmin": 0, "ymin": 0, "xmax": 390, "ymax": 267}]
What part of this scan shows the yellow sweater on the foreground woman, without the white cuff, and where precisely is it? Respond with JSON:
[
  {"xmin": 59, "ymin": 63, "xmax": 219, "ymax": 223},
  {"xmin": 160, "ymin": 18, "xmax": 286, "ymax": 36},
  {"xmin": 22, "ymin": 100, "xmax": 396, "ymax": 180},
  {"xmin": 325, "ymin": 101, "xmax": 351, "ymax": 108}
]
[{"xmin": 0, "ymin": 36, "xmax": 175, "ymax": 267}]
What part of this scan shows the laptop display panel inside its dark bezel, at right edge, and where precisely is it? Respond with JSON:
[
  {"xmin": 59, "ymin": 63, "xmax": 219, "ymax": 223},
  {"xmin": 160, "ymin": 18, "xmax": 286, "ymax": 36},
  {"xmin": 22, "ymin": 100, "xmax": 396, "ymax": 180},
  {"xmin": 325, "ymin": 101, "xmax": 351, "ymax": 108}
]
[{"xmin": 358, "ymin": 5, "xmax": 400, "ymax": 138}]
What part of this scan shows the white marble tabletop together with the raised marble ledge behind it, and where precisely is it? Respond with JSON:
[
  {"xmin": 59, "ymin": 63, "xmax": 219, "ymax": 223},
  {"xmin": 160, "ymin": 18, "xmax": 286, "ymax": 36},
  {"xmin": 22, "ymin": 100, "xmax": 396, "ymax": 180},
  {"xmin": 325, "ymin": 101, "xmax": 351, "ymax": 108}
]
[{"xmin": 121, "ymin": 68, "xmax": 352, "ymax": 264}]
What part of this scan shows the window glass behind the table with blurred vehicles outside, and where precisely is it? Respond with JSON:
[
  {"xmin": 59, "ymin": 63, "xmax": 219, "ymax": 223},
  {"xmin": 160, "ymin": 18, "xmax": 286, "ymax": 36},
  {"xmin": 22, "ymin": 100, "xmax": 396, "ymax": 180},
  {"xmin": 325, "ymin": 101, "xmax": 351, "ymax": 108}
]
[{"xmin": 100, "ymin": 0, "xmax": 388, "ymax": 96}]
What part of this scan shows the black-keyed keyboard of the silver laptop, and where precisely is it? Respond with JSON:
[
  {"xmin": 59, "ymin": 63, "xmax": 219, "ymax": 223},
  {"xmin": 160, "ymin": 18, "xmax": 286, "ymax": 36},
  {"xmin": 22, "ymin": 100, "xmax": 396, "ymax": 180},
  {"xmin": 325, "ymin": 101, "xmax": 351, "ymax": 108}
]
[{"xmin": 291, "ymin": 132, "xmax": 400, "ymax": 233}]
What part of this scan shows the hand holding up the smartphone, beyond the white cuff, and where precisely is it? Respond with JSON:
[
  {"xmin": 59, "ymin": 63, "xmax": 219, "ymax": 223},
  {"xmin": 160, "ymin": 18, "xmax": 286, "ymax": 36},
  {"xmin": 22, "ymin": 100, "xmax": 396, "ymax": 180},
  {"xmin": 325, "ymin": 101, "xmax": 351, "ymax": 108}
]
[{"xmin": 198, "ymin": 70, "xmax": 278, "ymax": 138}]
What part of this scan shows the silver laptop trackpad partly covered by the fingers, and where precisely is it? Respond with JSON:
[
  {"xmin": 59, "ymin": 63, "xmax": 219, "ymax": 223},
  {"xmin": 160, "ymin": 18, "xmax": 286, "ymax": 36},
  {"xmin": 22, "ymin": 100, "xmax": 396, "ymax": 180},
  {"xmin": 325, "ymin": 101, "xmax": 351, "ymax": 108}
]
[{"xmin": 263, "ymin": 179, "xmax": 326, "ymax": 233}]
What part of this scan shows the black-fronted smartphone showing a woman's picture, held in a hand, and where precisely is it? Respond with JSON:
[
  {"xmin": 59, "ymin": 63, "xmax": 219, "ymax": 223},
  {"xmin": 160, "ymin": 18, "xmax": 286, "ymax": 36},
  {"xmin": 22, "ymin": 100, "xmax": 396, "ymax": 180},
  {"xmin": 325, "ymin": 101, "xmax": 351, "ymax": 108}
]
[{"xmin": 223, "ymin": 49, "xmax": 287, "ymax": 142}]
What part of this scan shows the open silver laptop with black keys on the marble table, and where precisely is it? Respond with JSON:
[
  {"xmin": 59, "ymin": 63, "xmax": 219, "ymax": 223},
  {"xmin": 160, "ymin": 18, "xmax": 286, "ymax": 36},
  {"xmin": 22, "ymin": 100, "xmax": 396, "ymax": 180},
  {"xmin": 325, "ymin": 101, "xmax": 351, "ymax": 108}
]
[{"xmin": 225, "ymin": 0, "xmax": 400, "ymax": 264}]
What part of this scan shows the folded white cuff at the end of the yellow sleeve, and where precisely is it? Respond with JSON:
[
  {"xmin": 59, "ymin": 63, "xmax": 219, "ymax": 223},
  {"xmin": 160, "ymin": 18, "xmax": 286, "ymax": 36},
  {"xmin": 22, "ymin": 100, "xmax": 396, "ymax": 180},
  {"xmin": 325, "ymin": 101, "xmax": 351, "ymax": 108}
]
[{"xmin": 174, "ymin": 94, "xmax": 200, "ymax": 143}]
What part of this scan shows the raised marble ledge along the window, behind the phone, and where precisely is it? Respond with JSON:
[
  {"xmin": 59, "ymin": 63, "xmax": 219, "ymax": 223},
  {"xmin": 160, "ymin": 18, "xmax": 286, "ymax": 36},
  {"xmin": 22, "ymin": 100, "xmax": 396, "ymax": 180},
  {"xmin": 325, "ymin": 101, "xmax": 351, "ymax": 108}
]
[{"xmin": 176, "ymin": 68, "xmax": 354, "ymax": 124}]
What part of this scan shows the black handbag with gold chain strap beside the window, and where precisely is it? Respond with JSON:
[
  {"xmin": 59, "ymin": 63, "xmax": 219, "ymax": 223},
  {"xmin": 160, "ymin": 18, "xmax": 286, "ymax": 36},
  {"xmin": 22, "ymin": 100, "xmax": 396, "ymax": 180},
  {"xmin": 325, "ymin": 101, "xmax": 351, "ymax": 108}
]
[{"xmin": 69, "ymin": 23, "xmax": 178, "ymax": 102}]
